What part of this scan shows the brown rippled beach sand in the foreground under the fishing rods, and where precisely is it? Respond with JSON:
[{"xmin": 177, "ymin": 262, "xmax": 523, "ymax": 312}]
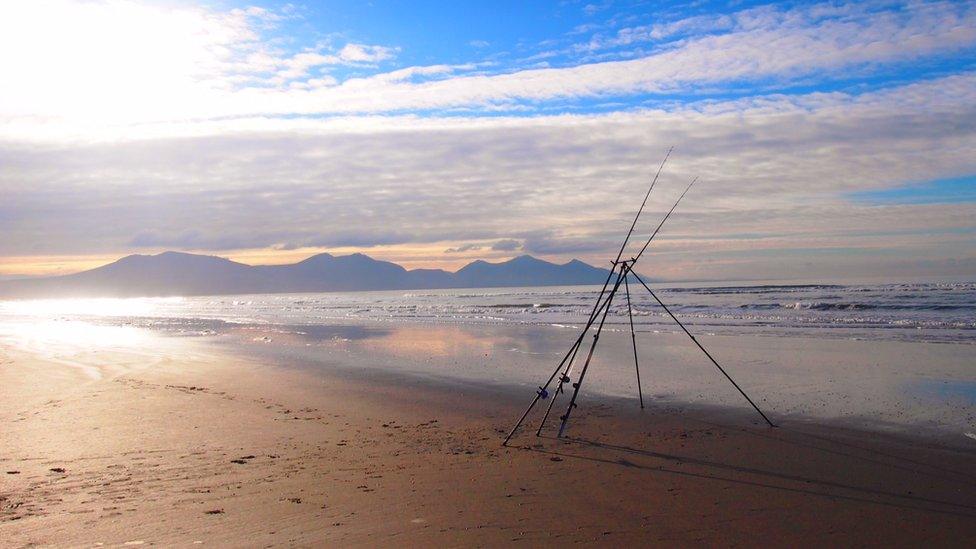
[{"xmin": 0, "ymin": 336, "xmax": 976, "ymax": 547}]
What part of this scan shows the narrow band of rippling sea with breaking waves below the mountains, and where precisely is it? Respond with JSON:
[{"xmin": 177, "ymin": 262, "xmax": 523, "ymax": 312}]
[{"xmin": 0, "ymin": 282, "xmax": 976, "ymax": 344}]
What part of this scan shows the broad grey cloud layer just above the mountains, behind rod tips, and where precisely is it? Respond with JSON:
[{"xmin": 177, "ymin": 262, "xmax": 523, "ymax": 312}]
[{"xmin": 0, "ymin": 71, "xmax": 976, "ymax": 277}]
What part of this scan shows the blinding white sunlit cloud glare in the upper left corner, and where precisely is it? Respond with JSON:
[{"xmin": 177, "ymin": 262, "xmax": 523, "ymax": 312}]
[{"xmin": 0, "ymin": 0, "xmax": 398, "ymax": 128}]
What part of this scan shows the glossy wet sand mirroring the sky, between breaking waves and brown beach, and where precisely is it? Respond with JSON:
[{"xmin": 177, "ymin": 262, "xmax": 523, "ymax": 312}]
[{"xmin": 0, "ymin": 302, "xmax": 976, "ymax": 434}]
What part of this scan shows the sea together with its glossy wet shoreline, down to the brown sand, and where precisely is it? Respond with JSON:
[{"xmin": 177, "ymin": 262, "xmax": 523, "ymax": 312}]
[{"xmin": 0, "ymin": 281, "xmax": 976, "ymax": 436}]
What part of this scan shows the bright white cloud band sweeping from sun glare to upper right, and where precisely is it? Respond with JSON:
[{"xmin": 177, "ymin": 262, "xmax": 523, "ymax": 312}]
[{"xmin": 0, "ymin": 2, "xmax": 976, "ymax": 139}]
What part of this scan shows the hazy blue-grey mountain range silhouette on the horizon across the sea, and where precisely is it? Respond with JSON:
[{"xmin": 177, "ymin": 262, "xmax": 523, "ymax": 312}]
[{"xmin": 0, "ymin": 252, "xmax": 609, "ymax": 298}]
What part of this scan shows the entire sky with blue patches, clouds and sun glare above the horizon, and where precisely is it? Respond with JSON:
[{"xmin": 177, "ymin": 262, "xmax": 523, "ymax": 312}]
[{"xmin": 0, "ymin": 0, "xmax": 976, "ymax": 280}]
